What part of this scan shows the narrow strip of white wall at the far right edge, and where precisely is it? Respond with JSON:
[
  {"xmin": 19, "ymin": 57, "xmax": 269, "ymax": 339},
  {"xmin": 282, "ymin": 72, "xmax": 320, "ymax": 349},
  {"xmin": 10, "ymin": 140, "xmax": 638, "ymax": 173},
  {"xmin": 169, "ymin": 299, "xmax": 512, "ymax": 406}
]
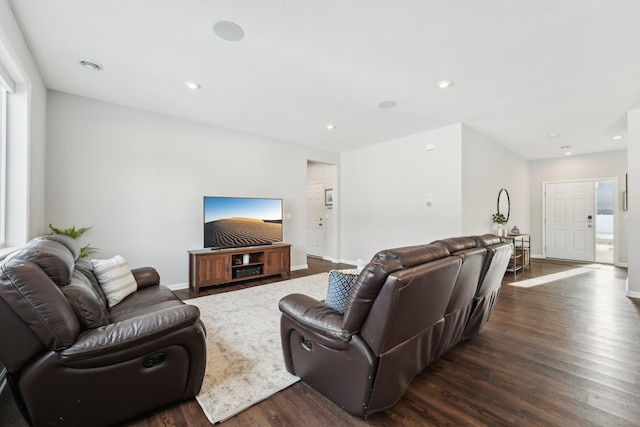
[{"xmin": 627, "ymin": 109, "xmax": 640, "ymax": 298}]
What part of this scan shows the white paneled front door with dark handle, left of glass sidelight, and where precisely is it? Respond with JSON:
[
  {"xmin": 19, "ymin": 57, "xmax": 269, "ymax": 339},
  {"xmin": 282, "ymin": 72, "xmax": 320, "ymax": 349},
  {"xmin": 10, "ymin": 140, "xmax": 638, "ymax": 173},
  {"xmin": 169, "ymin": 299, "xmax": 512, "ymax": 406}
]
[{"xmin": 545, "ymin": 181, "xmax": 595, "ymax": 262}]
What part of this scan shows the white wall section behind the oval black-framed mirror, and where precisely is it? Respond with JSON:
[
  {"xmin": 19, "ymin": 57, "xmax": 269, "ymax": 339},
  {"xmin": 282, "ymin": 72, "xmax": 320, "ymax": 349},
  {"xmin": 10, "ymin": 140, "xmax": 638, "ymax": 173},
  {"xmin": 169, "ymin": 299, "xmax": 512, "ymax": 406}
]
[{"xmin": 462, "ymin": 126, "xmax": 531, "ymax": 235}]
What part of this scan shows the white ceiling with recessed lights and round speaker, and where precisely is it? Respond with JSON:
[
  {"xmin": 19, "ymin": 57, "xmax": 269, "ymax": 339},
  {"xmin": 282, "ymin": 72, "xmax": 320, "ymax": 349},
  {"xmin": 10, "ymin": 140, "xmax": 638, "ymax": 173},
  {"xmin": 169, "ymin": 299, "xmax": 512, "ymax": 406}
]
[{"xmin": 11, "ymin": 0, "xmax": 640, "ymax": 159}]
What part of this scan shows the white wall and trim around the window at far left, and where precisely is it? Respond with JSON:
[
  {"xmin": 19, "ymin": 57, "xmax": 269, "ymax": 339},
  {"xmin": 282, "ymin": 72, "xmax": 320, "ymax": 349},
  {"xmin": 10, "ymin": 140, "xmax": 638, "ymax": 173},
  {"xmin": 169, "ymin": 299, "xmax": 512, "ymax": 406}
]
[{"xmin": 0, "ymin": 0, "xmax": 47, "ymax": 242}]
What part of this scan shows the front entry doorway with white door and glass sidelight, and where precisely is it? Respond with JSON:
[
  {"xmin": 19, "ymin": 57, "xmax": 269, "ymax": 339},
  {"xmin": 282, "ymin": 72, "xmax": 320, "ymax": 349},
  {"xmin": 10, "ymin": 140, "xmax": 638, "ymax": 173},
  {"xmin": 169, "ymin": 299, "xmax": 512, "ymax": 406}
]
[{"xmin": 544, "ymin": 179, "xmax": 616, "ymax": 264}]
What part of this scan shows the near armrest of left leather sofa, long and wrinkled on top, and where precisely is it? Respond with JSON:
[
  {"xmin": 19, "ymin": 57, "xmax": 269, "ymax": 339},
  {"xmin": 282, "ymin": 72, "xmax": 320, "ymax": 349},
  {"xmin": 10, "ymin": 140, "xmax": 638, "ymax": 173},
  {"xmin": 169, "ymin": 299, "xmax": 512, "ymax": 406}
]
[{"xmin": 59, "ymin": 304, "xmax": 200, "ymax": 361}]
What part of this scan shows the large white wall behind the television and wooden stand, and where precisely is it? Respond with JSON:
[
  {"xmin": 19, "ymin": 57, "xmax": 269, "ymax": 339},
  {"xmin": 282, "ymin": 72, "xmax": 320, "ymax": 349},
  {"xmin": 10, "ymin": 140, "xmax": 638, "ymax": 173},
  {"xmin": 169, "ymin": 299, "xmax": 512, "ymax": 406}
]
[{"xmin": 46, "ymin": 92, "xmax": 339, "ymax": 285}]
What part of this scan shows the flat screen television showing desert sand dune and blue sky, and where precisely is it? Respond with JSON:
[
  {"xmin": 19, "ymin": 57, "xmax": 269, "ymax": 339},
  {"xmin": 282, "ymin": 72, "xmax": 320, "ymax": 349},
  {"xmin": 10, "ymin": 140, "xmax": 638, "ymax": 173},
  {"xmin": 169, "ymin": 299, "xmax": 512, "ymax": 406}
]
[{"xmin": 204, "ymin": 196, "xmax": 282, "ymax": 249}]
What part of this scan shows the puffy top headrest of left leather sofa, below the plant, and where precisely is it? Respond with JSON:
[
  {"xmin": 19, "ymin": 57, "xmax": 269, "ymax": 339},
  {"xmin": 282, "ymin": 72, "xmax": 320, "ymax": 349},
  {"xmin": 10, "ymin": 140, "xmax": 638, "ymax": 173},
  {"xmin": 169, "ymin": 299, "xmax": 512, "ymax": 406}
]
[{"xmin": 8, "ymin": 236, "xmax": 80, "ymax": 286}]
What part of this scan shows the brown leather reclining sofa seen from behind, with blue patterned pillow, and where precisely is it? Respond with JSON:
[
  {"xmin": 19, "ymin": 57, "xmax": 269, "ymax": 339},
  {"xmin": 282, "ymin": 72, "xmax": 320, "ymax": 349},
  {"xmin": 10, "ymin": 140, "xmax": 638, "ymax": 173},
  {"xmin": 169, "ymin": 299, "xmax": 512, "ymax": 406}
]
[{"xmin": 279, "ymin": 235, "xmax": 511, "ymax": 418}]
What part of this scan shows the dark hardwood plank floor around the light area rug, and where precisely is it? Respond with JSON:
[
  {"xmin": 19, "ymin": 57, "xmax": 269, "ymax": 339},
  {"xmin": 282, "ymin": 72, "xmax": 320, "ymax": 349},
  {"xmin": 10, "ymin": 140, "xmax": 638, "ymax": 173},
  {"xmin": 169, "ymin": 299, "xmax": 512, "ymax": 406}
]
[{"xmin": 0, "ymin": 259, "xmax": 640, "ymax": 427}]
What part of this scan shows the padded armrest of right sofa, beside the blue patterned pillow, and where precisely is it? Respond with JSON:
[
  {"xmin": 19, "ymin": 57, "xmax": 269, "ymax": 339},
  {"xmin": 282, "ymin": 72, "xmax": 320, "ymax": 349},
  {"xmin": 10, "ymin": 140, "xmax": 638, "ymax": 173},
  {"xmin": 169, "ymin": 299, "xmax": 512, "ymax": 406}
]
[{"xmin": 278, "ymin": 294, "xmax": 351, "ymax": 343}]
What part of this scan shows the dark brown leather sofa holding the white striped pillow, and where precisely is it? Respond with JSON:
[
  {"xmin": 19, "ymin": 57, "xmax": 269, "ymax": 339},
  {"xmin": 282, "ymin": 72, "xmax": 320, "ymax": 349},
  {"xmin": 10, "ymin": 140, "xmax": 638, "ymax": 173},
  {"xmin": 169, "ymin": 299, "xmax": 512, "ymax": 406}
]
[{"xmin": 0, "ymin": 236, "xmax": 206, "ymax": 426}]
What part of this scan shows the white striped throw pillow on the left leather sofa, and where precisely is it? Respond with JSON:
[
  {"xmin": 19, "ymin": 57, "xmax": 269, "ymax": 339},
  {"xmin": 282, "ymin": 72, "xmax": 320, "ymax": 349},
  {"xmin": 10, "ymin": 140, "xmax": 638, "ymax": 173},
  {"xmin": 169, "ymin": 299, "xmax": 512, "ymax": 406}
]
[{"xmin": 91, "ymin": 255, "xmax": 138, "ymax": 307}]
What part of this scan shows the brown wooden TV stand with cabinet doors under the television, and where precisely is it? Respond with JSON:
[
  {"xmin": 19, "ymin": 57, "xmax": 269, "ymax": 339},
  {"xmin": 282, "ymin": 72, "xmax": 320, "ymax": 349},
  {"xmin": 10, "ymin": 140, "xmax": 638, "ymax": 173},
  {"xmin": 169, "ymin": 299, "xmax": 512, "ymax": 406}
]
[{"xmin": 189, "ymin": 243, "xmax": 291, "ymax": 296}]
